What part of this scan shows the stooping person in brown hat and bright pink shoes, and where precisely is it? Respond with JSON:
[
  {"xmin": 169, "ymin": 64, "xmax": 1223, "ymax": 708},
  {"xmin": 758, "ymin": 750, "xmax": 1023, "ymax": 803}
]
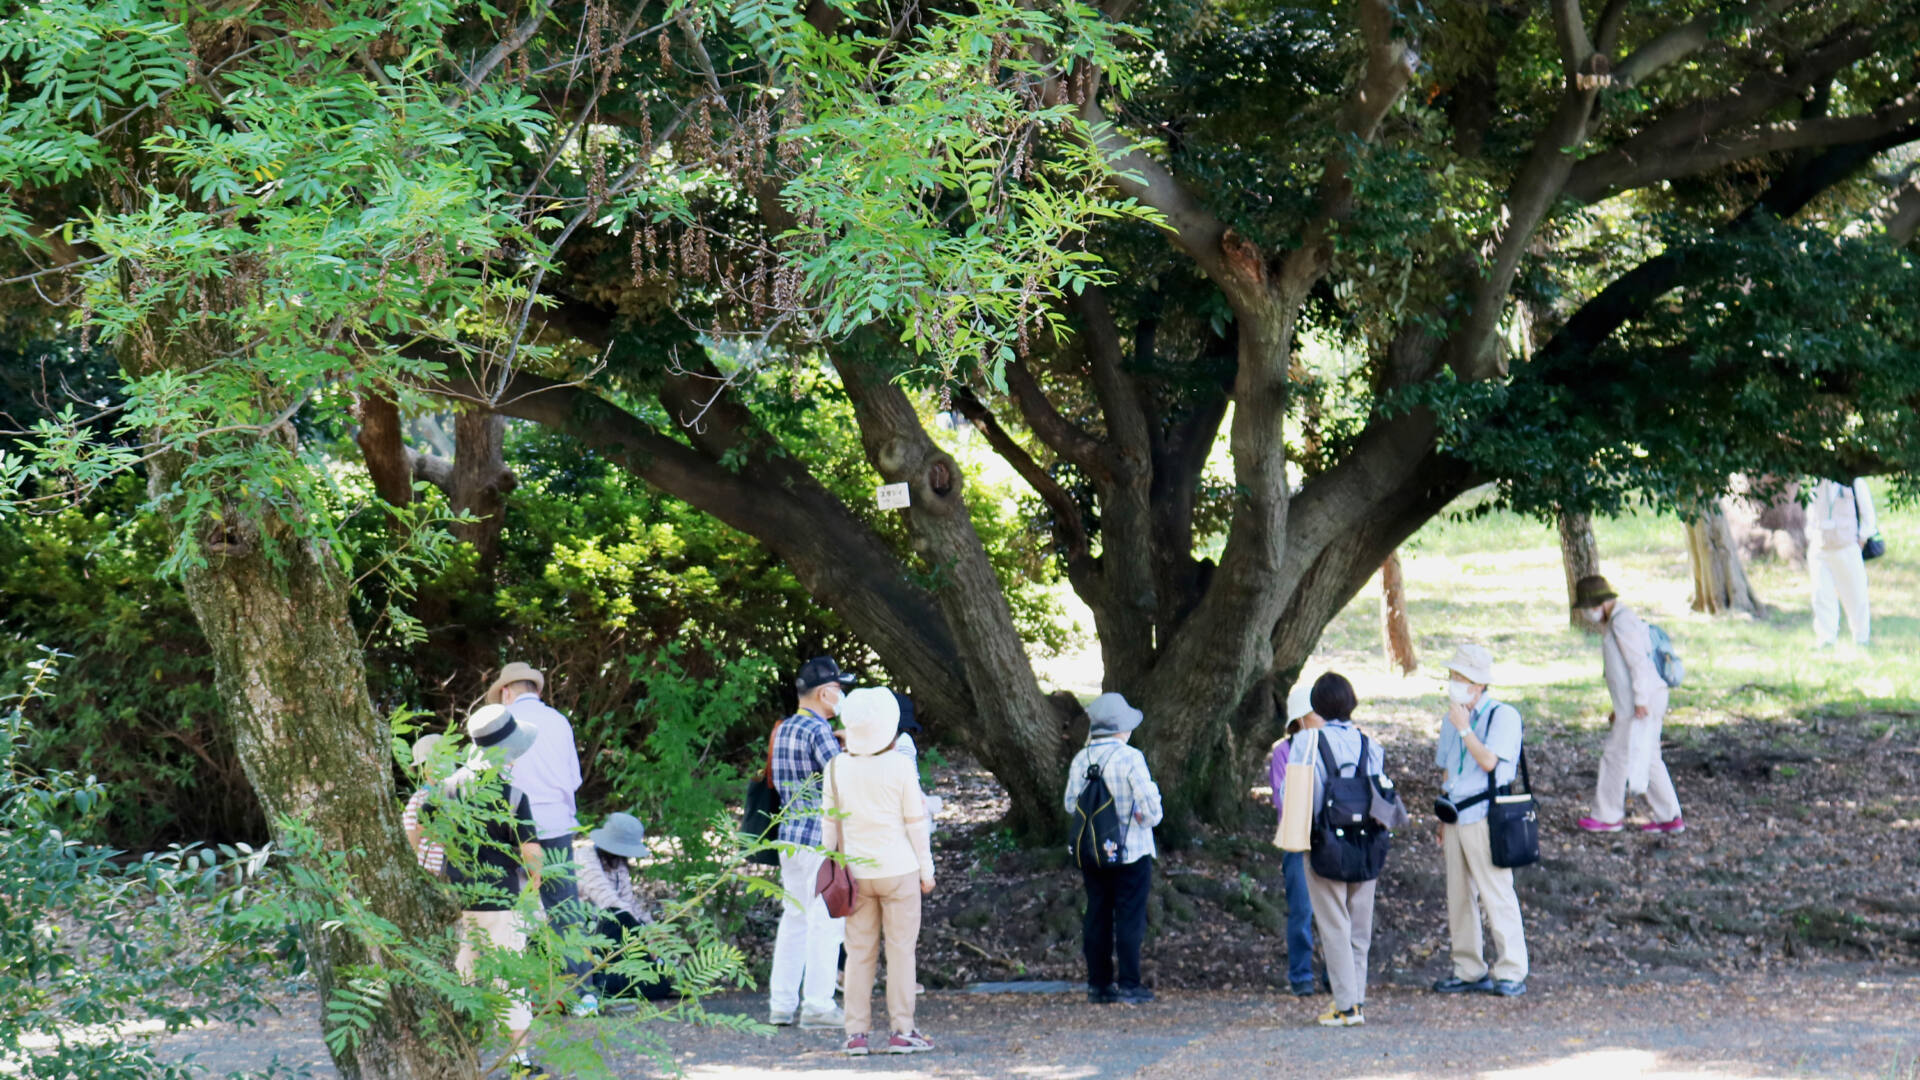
[{"xmin": 1572, "ymin": 575, "xmax": 1686, "ymax": 832}]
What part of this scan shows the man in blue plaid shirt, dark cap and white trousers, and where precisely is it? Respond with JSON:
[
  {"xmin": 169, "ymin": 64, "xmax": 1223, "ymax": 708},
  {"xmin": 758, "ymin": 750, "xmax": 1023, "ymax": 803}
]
[{"xmin": 766, "ymin": 657, "xmax": 852, "ymax": 1030}]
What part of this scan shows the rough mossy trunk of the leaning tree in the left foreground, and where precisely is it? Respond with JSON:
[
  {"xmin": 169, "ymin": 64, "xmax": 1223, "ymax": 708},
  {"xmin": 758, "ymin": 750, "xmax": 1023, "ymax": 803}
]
[{"xmin": 150, "ymin": 447, "xmax": 464, "ymax": 1080}]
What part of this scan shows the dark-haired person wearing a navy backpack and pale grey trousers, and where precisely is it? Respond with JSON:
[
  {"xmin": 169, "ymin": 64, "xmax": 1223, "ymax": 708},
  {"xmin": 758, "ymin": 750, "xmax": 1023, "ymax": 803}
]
[{"xmin": 1277, "ymin": 671, "xmax": 1388, "ymax": 1028}]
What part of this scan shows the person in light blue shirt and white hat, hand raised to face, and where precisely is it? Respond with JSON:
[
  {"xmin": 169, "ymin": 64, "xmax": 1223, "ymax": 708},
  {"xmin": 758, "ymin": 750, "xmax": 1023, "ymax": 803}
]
[{"xmin": 1434, "ymin": 644, "xmax": 1526, "ymax": 997}]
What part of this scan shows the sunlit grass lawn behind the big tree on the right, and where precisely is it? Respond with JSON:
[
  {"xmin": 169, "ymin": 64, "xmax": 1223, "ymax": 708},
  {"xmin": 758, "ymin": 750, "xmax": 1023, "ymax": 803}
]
[{"xmin": 1306, "ymin": 490, "xmax": 1920, "ymax": 744}]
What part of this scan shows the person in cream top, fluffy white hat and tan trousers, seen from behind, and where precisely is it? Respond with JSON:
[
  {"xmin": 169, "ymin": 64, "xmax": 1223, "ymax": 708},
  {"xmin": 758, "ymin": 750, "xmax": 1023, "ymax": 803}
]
[{"xmin": 822, "ymin": 686, "xmax": 933, "ymax": 1057}]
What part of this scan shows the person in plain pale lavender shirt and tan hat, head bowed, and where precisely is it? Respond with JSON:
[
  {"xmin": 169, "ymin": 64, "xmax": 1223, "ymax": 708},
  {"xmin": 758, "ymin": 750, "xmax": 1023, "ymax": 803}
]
[{"xmin": 486, "ymin": 661, "xmax": 599, "ymax": 1015}]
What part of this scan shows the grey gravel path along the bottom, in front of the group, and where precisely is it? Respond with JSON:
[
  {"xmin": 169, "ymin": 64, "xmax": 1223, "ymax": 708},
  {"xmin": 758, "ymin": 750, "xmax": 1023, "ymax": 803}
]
[{"xmin": 153, "ymin": 970, "xmax": 1920, "ymax": 1080}]
